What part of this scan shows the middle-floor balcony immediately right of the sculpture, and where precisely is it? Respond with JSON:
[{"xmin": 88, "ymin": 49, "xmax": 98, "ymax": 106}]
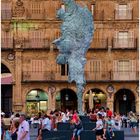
[{"xmin": 90, "ymin": 38, "xmax": 108, "ymax": 49}]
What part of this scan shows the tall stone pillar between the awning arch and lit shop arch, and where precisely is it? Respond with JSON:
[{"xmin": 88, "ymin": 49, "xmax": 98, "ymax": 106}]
[{"xmin": 13, "ymin": 50, "xmax": 23, "ymax": 112}]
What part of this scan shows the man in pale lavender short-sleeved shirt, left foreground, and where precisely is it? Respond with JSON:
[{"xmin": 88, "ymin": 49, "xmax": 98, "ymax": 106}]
[{"xmin": 17, "ymin": 114, "xmax": 30, "ymax": 140}]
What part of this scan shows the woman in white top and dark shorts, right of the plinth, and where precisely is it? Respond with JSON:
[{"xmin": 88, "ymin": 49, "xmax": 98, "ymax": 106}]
[{"xmin": 93, "ymin": 114, "xmax": 103, "ymax": 140}]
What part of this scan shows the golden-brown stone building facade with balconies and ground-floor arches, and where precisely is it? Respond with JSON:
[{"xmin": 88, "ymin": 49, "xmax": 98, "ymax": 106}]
[{"xmin": 1, "ymin": 0, "xmax": 139, "ymax": 114}]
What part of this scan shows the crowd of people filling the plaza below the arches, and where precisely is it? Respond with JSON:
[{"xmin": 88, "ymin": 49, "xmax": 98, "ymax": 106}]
[{"xmin": 1, "ymin": 107, "xmax": 138, "ymax": 140}]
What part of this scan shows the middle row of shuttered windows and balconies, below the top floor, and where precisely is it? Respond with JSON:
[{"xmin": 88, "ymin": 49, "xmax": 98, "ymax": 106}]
[{"xmin": 1, "ymin": 29, "xmax": 138, "ymax": 49}]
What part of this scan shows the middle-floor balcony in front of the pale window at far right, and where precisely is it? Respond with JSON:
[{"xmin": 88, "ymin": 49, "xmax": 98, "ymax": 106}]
[{"xmin": 112, "ymin": 38, "xmax": 138, "ymax": 49}]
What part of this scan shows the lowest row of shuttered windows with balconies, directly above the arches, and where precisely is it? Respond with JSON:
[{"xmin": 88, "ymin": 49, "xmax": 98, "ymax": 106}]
[{"xmin": 23, "ymin": 59, "xmax": 139, "ymax": 81}]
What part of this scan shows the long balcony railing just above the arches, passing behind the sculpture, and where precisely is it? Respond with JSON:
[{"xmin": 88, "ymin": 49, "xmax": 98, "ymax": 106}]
[{"xmin": 22, "ymin": 71, "xmax": 139, "ymax": 82}]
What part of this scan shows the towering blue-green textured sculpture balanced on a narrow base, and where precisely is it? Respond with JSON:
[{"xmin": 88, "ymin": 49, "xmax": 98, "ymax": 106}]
[{"xmin": 53, "ymin": 0, "xmax": 93, "ymax": 114}]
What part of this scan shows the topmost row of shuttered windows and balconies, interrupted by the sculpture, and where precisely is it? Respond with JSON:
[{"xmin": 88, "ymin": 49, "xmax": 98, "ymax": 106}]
[{"xmin": 1, "ymin": 1, "xmax": 138, "ymax": 21}]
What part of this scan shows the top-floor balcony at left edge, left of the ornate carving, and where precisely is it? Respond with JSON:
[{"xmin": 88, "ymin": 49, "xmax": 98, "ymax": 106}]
[{"xmin": 1, "ymin": 10, "xmax": 12, "ymax": 20}]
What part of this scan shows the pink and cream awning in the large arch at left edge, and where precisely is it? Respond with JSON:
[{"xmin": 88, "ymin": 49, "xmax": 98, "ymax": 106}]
[{"xmin": 1, "ymin": 73, "xmax": 12, "ymax": 85}]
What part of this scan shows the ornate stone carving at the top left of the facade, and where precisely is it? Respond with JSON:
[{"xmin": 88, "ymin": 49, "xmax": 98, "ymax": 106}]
[{"xmin": 13, "ymin": 0, "xmax": 25, "ymax": 17}]
